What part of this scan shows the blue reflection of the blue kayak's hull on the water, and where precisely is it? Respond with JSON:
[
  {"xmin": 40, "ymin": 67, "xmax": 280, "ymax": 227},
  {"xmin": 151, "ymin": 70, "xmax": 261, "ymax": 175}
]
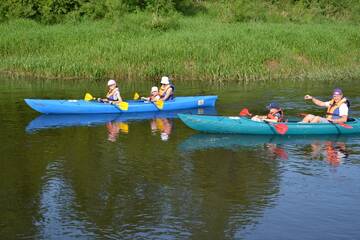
[{"xmin": 26, "ymin": 107, "xmax": 216, "ymax": 133}]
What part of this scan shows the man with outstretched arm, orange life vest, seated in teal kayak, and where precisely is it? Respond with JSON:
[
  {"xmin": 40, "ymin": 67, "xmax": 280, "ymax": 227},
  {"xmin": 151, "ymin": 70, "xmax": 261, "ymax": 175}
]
[{"xmin": 302, "ymin": 88, "xmax": 350, "ymax": 123}]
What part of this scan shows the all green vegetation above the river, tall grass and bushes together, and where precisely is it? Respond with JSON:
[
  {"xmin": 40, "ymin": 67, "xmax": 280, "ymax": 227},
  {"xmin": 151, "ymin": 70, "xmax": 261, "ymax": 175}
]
[{"xmin": 0, "ymin": 0, "xmax": 360, "ymax": 82}]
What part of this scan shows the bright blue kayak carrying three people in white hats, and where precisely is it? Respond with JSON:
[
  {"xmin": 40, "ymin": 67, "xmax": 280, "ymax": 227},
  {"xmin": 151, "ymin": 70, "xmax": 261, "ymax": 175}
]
[{"xmin": 25, "ymin": 96, "xmax": 217, "ymax": 114}]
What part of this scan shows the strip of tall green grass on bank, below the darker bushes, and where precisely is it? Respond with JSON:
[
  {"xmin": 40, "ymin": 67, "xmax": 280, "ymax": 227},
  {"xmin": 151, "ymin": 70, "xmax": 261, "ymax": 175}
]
[{"xmin": 0, "ymin": 14, "xmax": 360, "ymax": 83}]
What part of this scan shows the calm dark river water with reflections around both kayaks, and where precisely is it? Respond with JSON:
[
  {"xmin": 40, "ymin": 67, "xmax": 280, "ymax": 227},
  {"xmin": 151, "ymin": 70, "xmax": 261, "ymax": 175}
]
[{"xmin": 0, "ymin": 77, "xmax": 360, "ymax": 239}]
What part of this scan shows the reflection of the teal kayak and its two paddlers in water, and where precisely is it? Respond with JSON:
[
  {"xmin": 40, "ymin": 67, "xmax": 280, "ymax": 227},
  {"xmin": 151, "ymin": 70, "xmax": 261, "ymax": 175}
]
[{"xmin": 179, "ymin": 134, "xmax": 360, "ymax": 166}]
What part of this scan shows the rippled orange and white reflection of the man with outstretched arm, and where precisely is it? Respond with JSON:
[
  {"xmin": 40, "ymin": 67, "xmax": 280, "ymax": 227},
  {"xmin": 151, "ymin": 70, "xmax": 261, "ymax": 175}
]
[{"xmin": 311, "ymin": 141, "xmax": 349, "ymax": 167}]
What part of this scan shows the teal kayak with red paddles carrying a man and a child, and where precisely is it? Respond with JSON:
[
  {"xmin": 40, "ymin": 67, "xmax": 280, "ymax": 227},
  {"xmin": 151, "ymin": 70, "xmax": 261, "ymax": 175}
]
[{"xmin": 179, "ymin": 114, "xmax": 360, "ymax": 135}]
